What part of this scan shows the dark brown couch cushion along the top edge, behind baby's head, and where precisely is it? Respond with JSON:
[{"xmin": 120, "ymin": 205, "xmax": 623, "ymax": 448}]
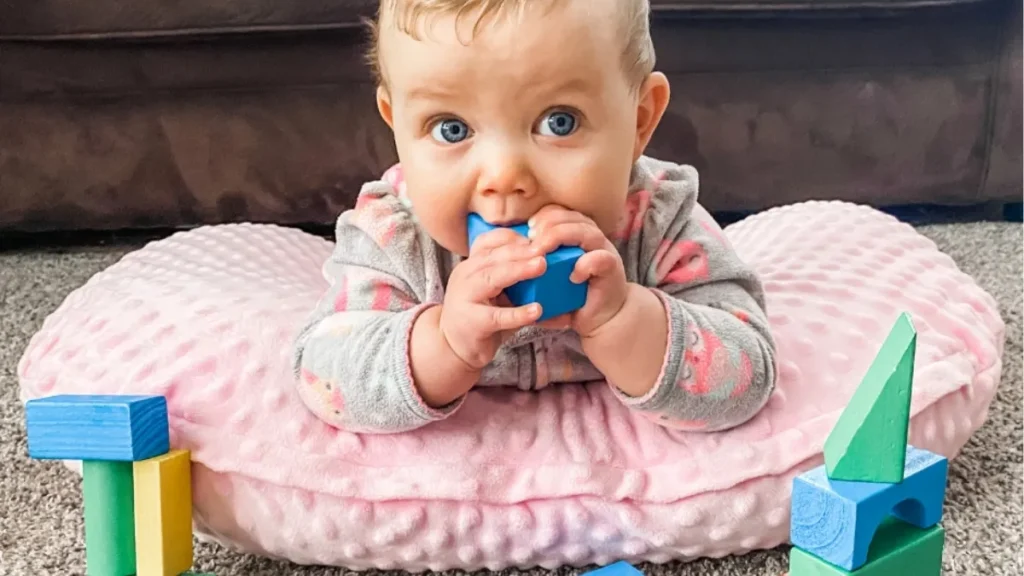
[{"xmin": 0, "ymin": 0, "xmax": 991, "ymax": 40}]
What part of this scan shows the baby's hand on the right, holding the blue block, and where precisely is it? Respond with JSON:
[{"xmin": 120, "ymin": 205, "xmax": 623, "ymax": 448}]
[{"xmin": 529, "ymin": 205, "xmax": 629, "ymax": 338}]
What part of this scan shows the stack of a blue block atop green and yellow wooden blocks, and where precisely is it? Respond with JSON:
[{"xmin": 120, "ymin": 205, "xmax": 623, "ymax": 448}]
[{"xmin": 25, "ymin": 396, "xmax": 207, "ymax": 576}]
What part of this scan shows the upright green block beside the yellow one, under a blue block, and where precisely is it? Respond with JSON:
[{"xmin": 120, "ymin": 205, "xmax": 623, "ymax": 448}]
[{"xmin": 82, "ymin": 460, "xmax": 135, "ymax": 576}]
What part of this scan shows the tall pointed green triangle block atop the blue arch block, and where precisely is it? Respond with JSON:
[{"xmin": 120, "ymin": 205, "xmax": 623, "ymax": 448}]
[{"xmin": 824, "ymin": 313, "xmax": 918, "ymax": 484}]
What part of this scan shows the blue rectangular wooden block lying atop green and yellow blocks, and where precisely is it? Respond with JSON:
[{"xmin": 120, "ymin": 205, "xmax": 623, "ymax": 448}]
[{"xmin": 25, "ymin": 395, "xmax": 170, "ymax": 461}]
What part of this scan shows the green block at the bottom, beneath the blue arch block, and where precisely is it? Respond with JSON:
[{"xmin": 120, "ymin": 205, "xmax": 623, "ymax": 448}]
[{"xmin": 790, "ymin": 518, "xmax": 945, "ymax": 576}]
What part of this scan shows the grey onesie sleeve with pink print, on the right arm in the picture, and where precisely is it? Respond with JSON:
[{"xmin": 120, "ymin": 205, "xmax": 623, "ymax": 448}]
[{"xmin": 615, "ymin": 159, "xmax": 776, "ymax": 431}]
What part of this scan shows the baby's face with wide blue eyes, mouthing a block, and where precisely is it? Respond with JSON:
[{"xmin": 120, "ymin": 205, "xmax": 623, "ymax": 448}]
[{"xmin": 378, "ymin": 0, "xmax": 668, "ymax": 255}]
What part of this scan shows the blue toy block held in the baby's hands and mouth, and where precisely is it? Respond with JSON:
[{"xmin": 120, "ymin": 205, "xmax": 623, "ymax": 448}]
[{"xmin": 466, "ymin": 214, "xmax": 587, "ymax": 321}]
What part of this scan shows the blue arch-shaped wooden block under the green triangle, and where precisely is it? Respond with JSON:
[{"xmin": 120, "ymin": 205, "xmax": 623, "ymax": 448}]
[{"xmin": 790, "ymin": 446, "xmax": 948, "ymax": 571}]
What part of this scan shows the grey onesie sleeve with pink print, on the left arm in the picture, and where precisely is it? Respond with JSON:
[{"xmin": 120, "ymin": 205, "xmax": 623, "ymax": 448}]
[{"xmin": 293, "ymin": 170, "xmax": 461, "ymax": 434}]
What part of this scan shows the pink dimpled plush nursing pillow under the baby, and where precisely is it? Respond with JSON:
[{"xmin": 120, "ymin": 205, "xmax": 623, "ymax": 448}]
[{"xmin": 19, "ymin": 202, "xmax": 1004, "ymax": 571}]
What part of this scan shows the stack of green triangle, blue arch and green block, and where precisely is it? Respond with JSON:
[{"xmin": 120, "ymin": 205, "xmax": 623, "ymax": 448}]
[{"xmin": 790, "ymin": 315, "xmax": 948, "ymax": 576}]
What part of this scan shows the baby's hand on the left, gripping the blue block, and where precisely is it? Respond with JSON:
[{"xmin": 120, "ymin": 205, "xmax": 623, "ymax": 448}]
[{"xmin": 439, "ymin": 229, "xmax": 547, "ymax": 370}]
